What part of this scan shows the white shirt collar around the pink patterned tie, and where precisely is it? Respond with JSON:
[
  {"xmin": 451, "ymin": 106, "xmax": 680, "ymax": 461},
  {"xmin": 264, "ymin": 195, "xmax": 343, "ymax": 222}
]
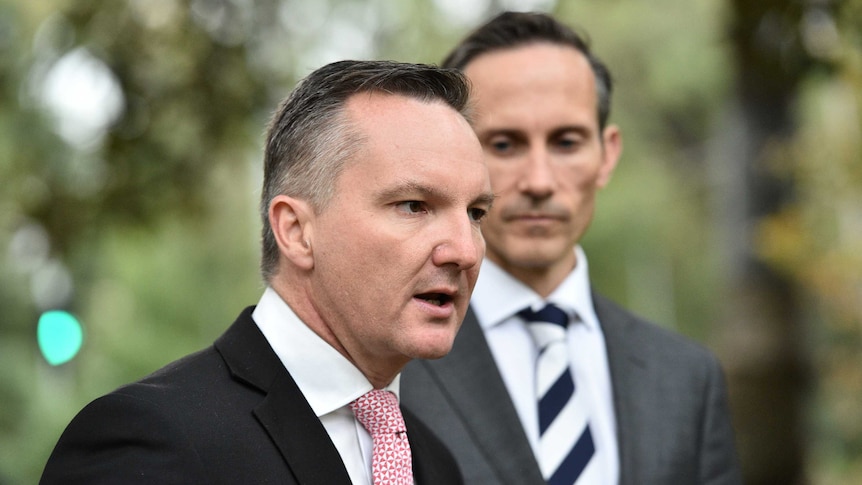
[{"xmin": 252, "ymin": 287, "xmax": 401, "ymax": 416}]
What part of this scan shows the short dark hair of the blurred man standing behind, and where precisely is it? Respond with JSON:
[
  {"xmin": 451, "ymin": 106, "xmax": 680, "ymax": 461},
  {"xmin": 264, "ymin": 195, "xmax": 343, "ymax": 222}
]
[{"xmin": 443, "ymin": 12, "xmax": 613, "ymax": 129}]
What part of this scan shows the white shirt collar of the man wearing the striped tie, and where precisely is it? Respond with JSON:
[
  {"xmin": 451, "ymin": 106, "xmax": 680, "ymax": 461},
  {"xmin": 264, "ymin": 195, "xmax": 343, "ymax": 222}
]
[{"xmin": 470, "ymin": 245, "xmax": 599, "ymax": 329}]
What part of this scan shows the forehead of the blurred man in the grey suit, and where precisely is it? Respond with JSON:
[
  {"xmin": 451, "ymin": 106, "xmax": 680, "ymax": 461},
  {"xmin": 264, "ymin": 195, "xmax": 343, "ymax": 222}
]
[{"xmin": 464, "ymin": 43, "xmax": 598, "ymax": 127}]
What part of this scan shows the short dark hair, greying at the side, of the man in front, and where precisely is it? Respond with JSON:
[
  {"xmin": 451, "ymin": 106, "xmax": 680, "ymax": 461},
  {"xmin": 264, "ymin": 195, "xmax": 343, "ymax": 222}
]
[{"xmin": 260, "ymin": 61, "xmax": 470, "ymax": 282}]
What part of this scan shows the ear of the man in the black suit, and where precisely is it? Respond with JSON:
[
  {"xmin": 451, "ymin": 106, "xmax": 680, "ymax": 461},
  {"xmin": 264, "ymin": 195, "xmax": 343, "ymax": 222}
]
[{"xmin": 269, "ymin": 195, "xmax": 314, "ymax": 270}]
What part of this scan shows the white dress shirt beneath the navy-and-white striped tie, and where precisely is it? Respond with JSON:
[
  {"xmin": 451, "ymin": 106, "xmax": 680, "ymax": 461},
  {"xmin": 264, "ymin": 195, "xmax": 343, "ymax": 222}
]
[{"xmin": 470, "ymin": 246, "xmax": 619, "ymax": 484}]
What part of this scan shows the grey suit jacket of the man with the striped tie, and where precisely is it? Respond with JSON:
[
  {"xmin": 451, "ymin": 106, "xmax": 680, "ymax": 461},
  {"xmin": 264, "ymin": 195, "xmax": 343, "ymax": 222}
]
[{"xmin": 401, "ymin": 295, "xmax": 741, "ymax": 485}]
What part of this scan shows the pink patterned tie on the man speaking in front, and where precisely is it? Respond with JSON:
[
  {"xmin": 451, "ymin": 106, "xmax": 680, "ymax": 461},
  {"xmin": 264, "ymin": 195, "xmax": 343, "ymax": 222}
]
[{"xmin": 350, "ymin": 389, "xmax": 413, "ymax": 485}]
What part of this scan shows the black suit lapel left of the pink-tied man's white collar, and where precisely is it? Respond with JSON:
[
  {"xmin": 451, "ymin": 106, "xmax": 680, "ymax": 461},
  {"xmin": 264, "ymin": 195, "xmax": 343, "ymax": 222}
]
[{"xmin": 215, "ymin": 308, "xmax": 350, "ymax": 484}]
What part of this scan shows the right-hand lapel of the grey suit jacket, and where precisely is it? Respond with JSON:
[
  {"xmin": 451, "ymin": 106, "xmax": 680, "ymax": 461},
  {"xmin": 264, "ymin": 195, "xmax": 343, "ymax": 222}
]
[{"xmin": 593, "ymin": 294, "xmax": 654, "ymax": 485}]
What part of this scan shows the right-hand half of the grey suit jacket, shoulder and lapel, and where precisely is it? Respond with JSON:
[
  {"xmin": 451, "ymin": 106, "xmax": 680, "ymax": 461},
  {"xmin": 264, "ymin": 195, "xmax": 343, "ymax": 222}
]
[{"xmin": 593, "ymin": 295, "xmax": 739, "ymax": 483}]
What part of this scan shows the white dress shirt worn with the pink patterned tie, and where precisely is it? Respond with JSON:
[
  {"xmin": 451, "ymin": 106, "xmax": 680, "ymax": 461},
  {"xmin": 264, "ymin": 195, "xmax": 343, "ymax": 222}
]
[{"xmin": 251, "ymin": 288, "xmax": 400, "ymax": 485}]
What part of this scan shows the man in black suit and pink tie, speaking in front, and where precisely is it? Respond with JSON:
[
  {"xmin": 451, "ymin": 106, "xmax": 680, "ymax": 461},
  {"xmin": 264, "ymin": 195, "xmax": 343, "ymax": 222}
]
[{"xmin": 41, "ymin": 61, "xmax": 500, "ymax": 485}]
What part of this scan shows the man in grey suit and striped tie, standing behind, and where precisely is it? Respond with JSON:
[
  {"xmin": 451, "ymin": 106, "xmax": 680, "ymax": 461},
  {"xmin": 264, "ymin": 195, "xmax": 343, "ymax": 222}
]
[{"xmin": 402, "ymin": 13, "xmax": 741, "ymax": 485}]
